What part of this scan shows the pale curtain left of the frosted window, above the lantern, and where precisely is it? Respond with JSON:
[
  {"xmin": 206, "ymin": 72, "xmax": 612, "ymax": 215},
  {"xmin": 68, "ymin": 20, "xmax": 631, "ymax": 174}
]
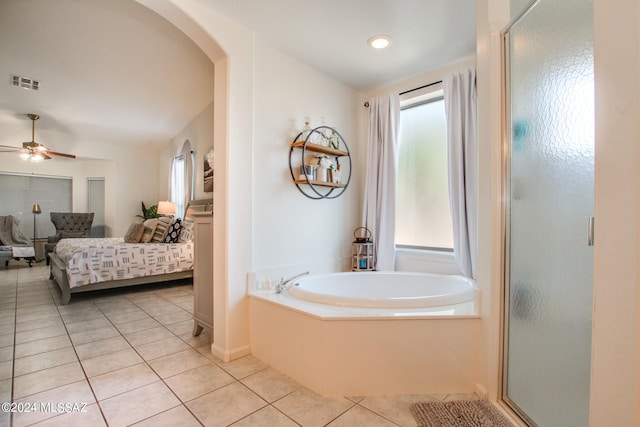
[{"xmin": 362, "ymin": 94, "xmax": 400, "ymax": 271}]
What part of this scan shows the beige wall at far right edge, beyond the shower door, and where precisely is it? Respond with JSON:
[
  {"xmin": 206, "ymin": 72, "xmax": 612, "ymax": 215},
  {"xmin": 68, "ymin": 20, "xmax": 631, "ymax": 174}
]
[{"xmin": 590, "ymin": 0, "xmax": 640, "ymax": 426}]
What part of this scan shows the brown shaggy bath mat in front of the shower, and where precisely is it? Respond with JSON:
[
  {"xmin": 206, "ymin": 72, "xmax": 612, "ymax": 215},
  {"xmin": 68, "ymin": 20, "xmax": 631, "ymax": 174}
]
[{"xmin": 410, "ymin": 400, "xmax": 514, "ymax": 427}]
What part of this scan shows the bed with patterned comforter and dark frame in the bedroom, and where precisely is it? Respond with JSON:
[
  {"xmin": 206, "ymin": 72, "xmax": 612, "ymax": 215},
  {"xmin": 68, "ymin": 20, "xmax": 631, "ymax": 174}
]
[{"xmin": 50, "ymin": 199, "xmax": 213, "ymax": 304}]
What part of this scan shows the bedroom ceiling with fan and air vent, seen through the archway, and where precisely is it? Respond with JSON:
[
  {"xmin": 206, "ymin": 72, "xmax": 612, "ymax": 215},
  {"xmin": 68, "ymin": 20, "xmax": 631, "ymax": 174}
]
[{"xmin": 0, "ymin": 0, "xmax": 214, "ymax": 154}]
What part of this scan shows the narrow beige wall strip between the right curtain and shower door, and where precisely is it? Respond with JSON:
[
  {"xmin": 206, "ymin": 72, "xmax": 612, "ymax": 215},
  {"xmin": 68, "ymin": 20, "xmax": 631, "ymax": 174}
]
[{"xmin": 476, "ymin": 0, "xmax": 510, "ymax": 400}]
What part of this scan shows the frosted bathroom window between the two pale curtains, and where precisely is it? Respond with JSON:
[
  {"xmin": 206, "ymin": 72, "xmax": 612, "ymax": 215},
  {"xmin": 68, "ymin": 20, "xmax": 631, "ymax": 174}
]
[{"xmin": 396, "ymin": 91, "xmax": 453, "ymax": 251}]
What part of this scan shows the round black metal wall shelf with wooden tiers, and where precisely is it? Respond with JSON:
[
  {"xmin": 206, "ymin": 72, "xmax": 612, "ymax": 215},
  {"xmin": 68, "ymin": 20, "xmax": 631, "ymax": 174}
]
[{"xmin": 289, "ymin": 126, "xmax": 351, "ymax": 200}]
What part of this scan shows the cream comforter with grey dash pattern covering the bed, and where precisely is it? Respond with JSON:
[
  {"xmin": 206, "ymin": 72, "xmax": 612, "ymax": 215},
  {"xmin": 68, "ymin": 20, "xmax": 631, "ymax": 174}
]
[{"xmin": 56, "ymin": 237, "xmax": 193, "ymax": 288}]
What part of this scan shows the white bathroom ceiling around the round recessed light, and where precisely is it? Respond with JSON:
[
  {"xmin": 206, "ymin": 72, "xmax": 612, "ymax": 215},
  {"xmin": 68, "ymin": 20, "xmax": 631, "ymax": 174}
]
[{"xmin": 200, "ymin": 0, "xmax": 476, "ymax": 92}]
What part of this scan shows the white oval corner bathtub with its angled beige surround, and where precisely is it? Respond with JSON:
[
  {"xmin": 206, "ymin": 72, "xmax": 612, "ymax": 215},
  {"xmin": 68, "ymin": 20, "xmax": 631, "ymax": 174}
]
[{"xmin": 249, "ymin": 272, "xmax": 481, "ymax": 396}]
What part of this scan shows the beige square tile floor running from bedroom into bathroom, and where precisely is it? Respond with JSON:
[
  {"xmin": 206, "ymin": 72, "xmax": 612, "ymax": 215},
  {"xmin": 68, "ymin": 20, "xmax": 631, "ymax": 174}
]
[{"xmin": 0, "ymin": 261, "xmax": 474, "ymax": 427}]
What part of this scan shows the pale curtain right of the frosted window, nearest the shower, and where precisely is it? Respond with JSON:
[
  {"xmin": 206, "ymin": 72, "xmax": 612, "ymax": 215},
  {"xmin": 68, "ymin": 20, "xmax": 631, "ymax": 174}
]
[{"xmin": 444, "ymin": 70, "xmax": 478, "ymax": 278}]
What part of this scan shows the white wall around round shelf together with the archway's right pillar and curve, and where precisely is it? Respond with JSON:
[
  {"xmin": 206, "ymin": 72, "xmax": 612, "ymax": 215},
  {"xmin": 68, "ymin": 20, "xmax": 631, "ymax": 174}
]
[{"xmin": 137, "ymin": 0, "xmax": 360, "ymax": 360}]
